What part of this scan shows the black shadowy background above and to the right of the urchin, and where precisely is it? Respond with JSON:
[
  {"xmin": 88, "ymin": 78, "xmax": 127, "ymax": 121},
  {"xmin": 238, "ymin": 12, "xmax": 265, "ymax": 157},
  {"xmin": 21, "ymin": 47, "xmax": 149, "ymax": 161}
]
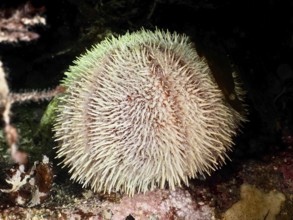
[{"xmin": 0, "ymin": 0, "xmax": 293, "ymax": 158}]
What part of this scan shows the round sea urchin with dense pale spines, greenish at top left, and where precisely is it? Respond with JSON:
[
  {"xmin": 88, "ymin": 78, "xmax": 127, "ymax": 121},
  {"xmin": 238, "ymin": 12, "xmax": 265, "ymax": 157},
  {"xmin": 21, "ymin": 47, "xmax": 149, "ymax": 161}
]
[{"xmin": 54, "ymin": 30, "xmax": 244, "ymax": 195}]
